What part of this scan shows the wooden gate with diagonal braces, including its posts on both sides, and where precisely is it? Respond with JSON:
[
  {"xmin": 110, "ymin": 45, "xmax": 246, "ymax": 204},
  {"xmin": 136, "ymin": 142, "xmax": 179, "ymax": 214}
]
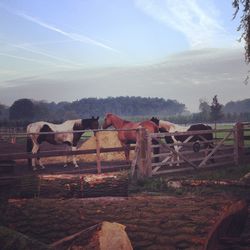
[{"xmin": 132, "ymin": 123, "xmax": 250, "ymax": 179}]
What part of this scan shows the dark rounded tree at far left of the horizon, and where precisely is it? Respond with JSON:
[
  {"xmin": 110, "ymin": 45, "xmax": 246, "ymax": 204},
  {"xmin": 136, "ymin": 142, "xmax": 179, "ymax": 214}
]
[{"xmin": 9, "ymin": 98, "xmax": 35, "ymax": 120}]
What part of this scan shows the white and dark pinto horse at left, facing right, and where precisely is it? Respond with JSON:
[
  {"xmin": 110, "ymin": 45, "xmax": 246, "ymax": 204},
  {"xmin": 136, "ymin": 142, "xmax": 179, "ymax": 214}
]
[{"xmin": 27, "ymin": 116, "xmax": 99, "ymax": 170}]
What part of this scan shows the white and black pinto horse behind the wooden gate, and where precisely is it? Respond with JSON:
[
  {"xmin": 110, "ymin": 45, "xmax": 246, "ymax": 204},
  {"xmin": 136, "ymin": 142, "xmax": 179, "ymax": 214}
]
[{"xmin": 151, "ymin": 117, "xmax": 214, "ymax": 165}]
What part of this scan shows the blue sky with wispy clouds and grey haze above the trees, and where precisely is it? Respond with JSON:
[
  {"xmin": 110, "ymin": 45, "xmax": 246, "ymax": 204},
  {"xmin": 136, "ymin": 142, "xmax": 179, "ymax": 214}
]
[{"xmin": 0, "ymin": 0, "xmax": 250, "ymax": 112}]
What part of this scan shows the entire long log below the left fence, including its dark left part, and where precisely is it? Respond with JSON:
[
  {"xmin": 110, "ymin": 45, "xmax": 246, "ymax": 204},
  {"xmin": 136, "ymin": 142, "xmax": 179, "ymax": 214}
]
[{"xmin": 0, "ymin": 171, "xmax": 128, "ymax": 198}]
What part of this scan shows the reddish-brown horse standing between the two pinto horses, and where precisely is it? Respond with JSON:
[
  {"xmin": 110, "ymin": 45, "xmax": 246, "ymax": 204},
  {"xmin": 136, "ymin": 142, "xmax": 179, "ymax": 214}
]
[{"xmin": 102, "ymin": 113, "xmax": 159, "ymax": 161}]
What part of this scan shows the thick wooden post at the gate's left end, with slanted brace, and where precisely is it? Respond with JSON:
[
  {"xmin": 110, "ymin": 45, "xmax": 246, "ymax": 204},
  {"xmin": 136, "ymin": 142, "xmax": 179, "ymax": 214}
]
[{"xmin": 133, "ymin": 127, "xmax": 152, "ymax": 180}]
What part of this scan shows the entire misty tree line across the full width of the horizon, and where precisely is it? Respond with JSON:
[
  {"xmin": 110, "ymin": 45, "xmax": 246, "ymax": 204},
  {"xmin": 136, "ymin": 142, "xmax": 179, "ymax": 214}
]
[{"xmin": 0, "ymin": 95, "xmax": 250, "ymax": 127}]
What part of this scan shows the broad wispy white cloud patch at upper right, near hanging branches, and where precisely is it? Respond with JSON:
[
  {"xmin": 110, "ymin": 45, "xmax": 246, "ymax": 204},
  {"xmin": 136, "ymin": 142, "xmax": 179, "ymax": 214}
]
[{"xmin": 135, "ymin": 0, "xmax": 232, "ymax": 48}]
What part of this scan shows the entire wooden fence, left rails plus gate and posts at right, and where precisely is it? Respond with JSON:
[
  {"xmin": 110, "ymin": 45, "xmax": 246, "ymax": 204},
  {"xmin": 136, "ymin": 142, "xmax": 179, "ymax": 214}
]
[{"xmin": 0, "ymin": 123, "xmax": 250, "ymax": 179}]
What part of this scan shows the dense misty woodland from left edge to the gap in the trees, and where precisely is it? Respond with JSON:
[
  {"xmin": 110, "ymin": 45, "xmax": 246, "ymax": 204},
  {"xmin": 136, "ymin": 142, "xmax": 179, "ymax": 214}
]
[{"xmin": 0, "ymin": 97, "xmax": 186, "ymax": 124}]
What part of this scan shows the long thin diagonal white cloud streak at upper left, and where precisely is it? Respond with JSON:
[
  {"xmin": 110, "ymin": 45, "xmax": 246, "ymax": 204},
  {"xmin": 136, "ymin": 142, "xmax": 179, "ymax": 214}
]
[{"xmin": 16, "ymin": 12, "xmax": 119, "ymax": 53}]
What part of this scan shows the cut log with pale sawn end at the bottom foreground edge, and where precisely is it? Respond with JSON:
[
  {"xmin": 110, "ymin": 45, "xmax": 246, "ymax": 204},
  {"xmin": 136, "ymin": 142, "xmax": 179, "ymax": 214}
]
[{"xmin": 50, "ymin": 221, "xmax": 133, "ymax": 250}]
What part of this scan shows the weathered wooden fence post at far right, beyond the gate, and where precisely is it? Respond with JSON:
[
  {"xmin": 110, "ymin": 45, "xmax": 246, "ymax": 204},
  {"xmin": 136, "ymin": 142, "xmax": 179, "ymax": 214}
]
[{"xmin": 234, "ymin": 122, "xmax": 244, "ymax": 165}]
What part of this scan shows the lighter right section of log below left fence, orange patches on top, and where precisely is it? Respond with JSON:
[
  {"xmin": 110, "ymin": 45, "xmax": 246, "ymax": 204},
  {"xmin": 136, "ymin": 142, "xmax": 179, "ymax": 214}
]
[{"xmin": 39, "ymin": 172, "xmax": 128, "ymax": 198}]
